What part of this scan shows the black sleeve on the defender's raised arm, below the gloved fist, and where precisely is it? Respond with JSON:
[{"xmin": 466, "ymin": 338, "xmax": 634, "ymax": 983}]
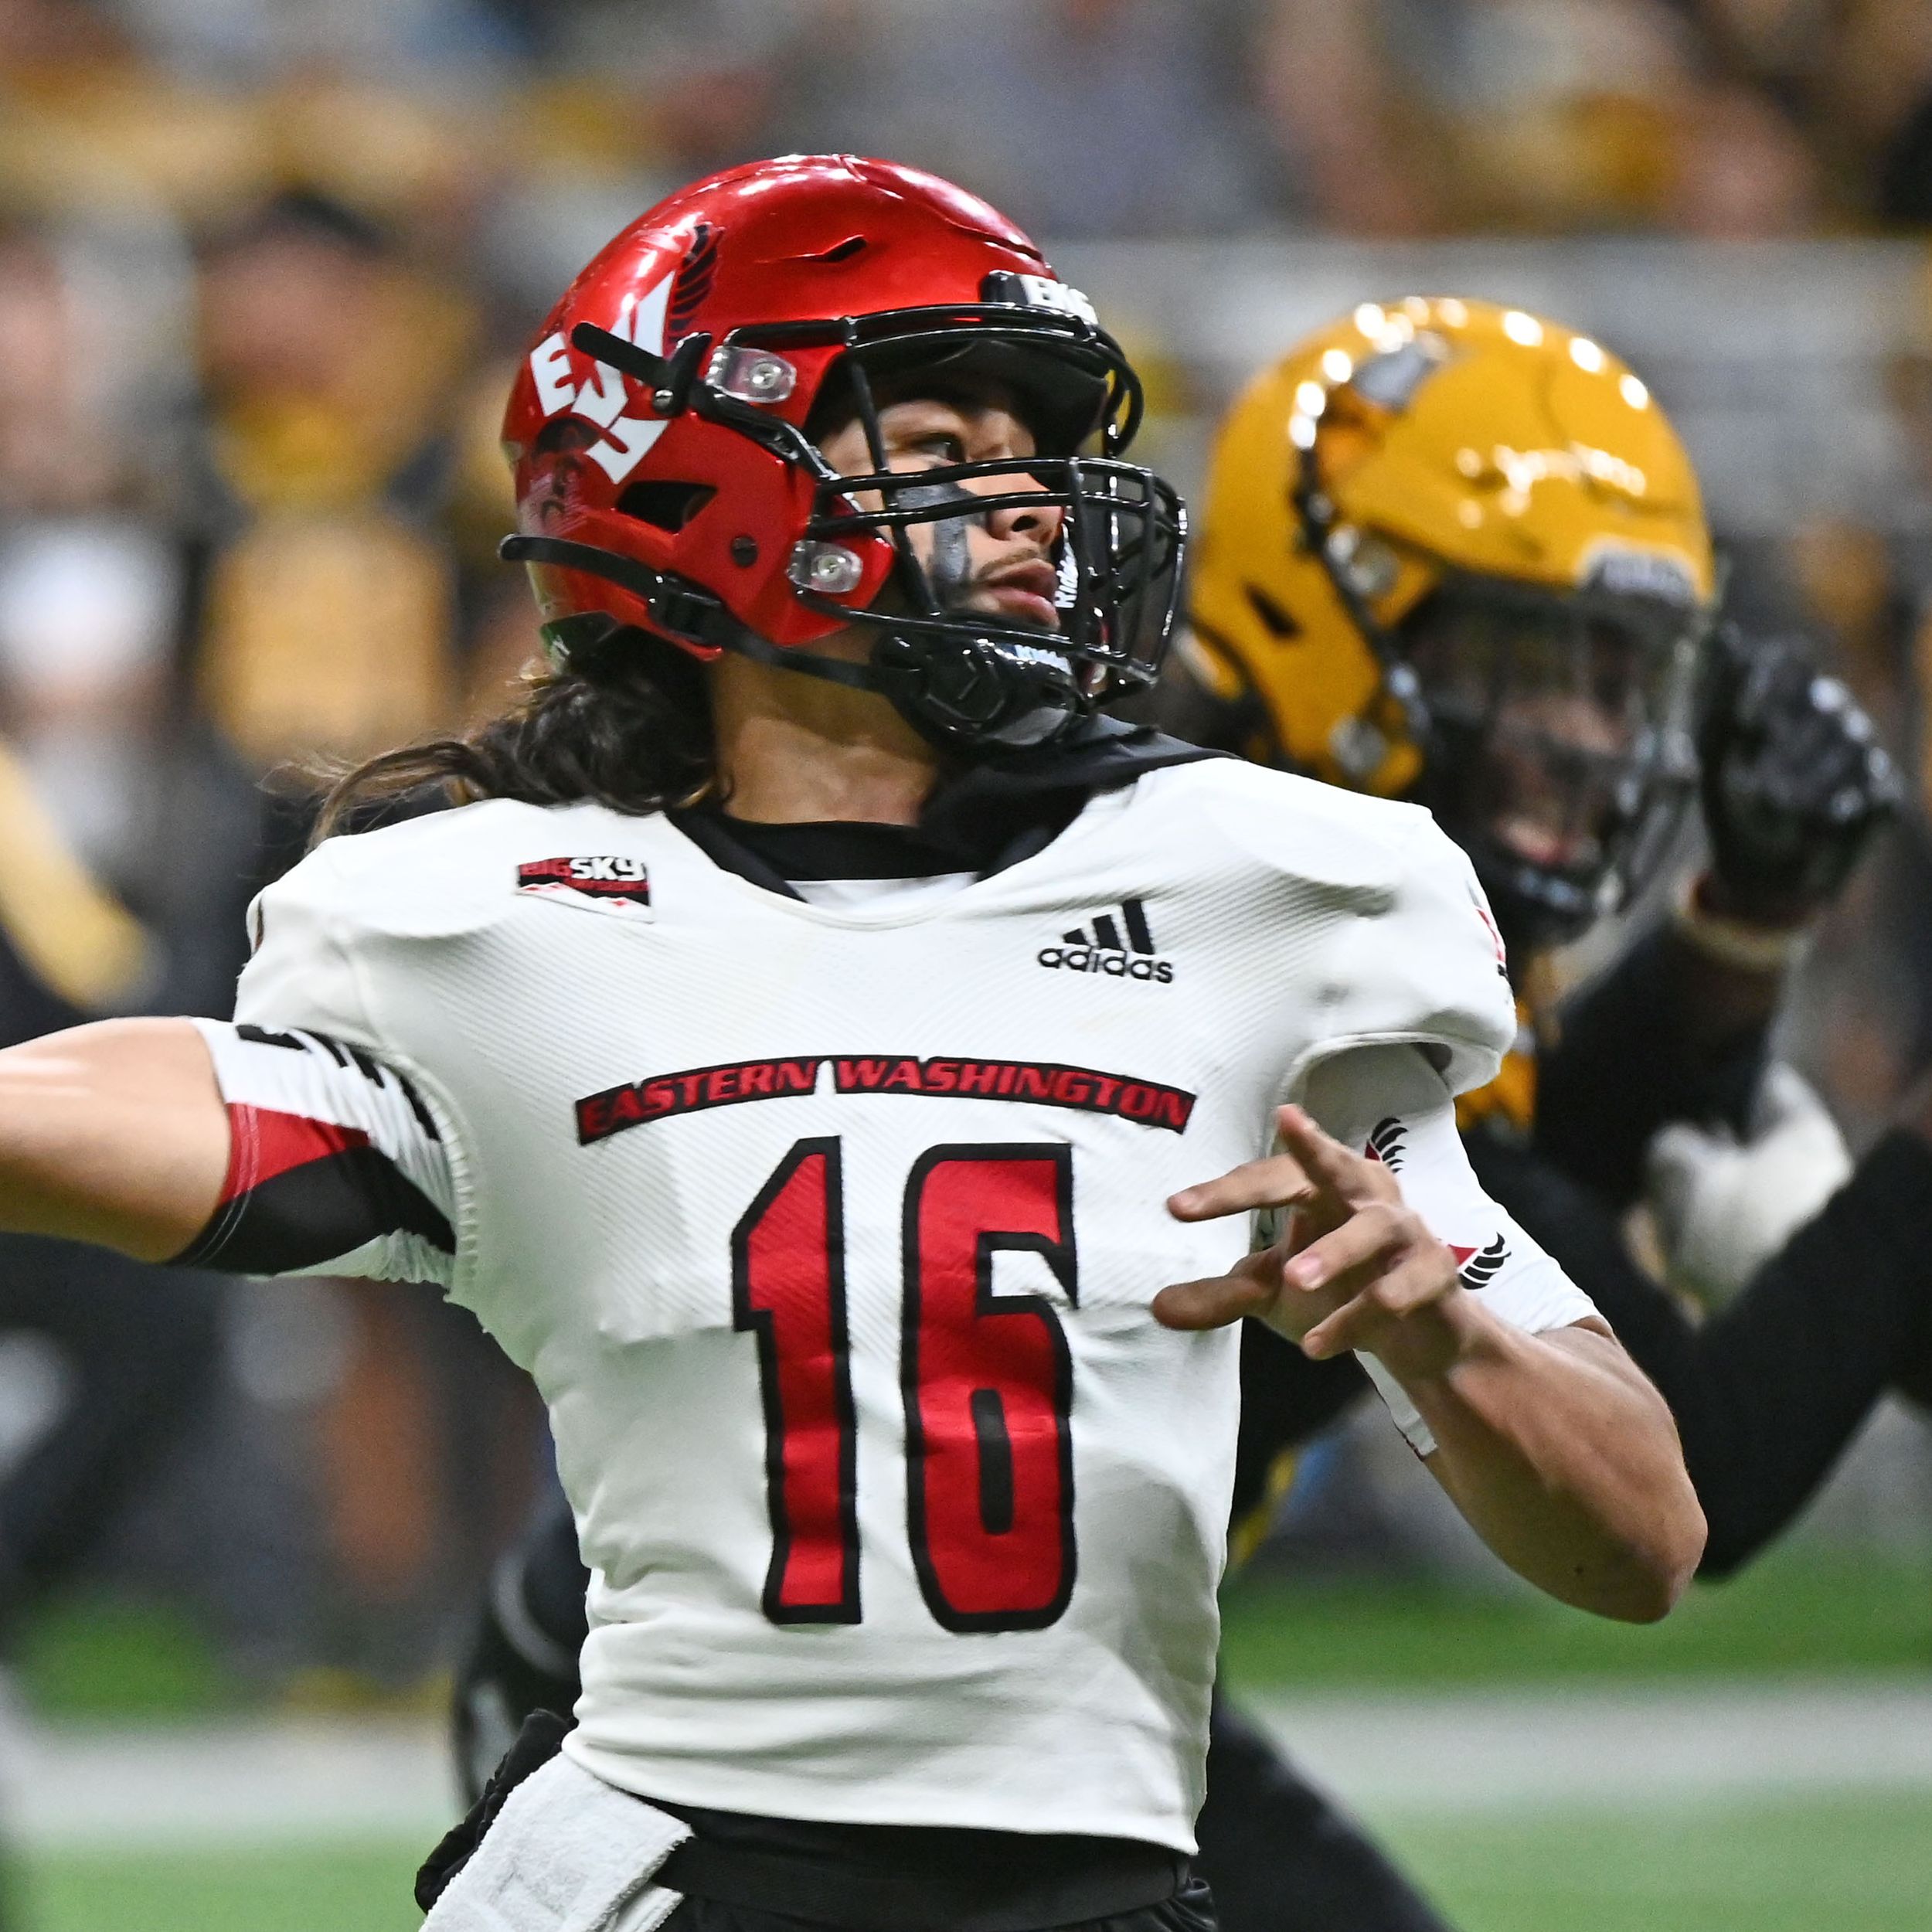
[{"xmin": 1536, "ymin": 926, "xmax": 1770, "ymax": 1206}]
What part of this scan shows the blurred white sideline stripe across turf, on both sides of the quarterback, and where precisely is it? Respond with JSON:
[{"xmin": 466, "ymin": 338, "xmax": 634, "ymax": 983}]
[{"xmin": 0, "ymin": 1675, "xmax": 1932, "ymax": 1851}]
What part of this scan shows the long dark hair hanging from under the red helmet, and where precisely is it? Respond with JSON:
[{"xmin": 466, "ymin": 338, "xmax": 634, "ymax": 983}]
[{"xmin": 309, "ymin": 626, "xmax": 717, "ymax": 845}]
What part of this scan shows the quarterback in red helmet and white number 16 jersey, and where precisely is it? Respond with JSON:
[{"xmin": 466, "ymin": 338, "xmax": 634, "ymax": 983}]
[{"xmin": 0, "ymin": 170, "xmax": 1704, "ymax": 1932}]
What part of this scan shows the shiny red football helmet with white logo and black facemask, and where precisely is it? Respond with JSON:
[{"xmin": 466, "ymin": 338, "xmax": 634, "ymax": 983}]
[{"xmin": 502, "ymin": 155, "xmax": 1185, "ymax": 750}]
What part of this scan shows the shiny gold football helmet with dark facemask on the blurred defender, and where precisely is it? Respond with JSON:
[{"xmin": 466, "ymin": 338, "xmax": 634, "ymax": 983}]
[{"xmin": 1186, "ymin": 296, "xmax": 1714, "ymax": 941}]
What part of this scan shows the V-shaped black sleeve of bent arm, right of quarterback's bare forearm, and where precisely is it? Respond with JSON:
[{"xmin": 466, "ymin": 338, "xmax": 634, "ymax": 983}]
[{"xmin": 1468, "ymin": 1131, "xmax": 1932, "ymax": 1577}]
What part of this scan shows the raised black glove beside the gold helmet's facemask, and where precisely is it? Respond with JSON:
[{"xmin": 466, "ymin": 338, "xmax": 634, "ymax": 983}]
[{"xmin": 1696, "ymin": 624, "xmax": 1901, "ymax": 926}]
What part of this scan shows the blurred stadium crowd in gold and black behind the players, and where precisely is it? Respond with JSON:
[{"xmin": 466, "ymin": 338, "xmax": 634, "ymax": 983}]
[{"xmin": 0, "ymin": 0, "xmax": 1932, "ymax": 1687}]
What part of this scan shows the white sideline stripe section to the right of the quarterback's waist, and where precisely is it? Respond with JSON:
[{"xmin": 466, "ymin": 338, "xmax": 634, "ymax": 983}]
[{"xmin": 1235, "ymin": 1675, "xmax": 1932, "ymax": 1828}]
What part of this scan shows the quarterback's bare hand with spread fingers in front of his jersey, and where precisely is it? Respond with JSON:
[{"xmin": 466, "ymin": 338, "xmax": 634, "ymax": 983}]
[{"xmin": 1154, "ymin": 1107, "xmax": 1463, "ymax": 1366}]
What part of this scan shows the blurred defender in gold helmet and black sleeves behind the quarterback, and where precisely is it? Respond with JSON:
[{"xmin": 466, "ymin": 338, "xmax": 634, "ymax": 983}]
[{"xmin": 1169, "ymin": 300, "xmax": 1909, "ymax": 1932}]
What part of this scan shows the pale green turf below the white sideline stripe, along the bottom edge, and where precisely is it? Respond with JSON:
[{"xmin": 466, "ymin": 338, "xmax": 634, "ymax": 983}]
[{"xmin": 19, "ymin": 1797, "xmax": 1932, "ymax": 1932}]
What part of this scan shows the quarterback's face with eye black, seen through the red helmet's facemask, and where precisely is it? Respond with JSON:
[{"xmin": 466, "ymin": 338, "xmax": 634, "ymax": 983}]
[{"xmin": 819, "ymin": 390, "xmax": 1063, "ymax": 632}]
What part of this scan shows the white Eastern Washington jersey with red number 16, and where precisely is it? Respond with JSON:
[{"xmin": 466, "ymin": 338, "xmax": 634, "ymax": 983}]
[{"xmin": 219, "ymin": 761, "xmax": 1590, "ymax": 1849}]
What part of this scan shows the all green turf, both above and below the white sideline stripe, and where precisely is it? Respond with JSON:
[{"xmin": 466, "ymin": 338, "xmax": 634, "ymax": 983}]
[{"xmin": 19, "ymin": 1548, "xmax": 1932, "ymax": 1932}]
